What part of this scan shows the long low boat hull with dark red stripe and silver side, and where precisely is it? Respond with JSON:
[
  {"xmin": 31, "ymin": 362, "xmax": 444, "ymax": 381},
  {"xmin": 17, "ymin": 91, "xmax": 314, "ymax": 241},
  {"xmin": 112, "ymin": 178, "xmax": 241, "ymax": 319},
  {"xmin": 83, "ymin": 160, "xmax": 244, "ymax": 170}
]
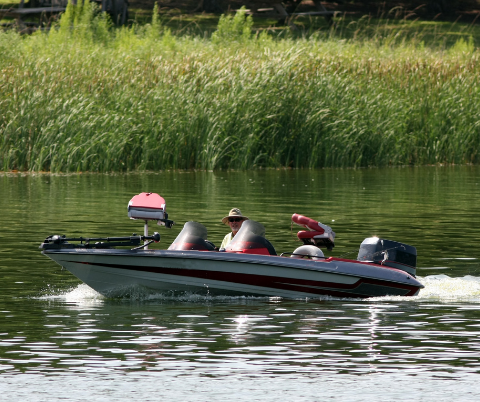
[{"xmin": 43, "ymin": 249, "xmax": 423, "ymax": 298}]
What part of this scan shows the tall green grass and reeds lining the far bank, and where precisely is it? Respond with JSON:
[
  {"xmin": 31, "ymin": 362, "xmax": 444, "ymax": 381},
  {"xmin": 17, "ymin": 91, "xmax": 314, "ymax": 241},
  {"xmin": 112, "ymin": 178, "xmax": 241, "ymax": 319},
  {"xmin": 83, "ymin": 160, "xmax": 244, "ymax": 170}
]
[{"xmin": 0, "ymin": 1, "xmax": 480, "ymax": 172}]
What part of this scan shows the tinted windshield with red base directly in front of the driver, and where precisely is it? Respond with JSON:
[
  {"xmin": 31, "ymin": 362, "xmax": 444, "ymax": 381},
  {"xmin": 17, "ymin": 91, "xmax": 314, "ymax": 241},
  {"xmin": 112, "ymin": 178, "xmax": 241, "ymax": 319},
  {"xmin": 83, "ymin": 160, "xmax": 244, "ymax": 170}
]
[{"xmin": 225, "ymin": 219, "xmax": 277, "ymax": 255}]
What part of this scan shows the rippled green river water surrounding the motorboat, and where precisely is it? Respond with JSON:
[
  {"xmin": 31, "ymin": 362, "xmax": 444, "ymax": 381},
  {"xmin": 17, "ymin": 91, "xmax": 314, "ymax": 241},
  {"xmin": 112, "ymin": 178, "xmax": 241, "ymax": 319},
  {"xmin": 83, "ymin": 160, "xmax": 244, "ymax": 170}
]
[{"xmin": 0, "ymin": 166, "xmax": 480, "ymax": 401}]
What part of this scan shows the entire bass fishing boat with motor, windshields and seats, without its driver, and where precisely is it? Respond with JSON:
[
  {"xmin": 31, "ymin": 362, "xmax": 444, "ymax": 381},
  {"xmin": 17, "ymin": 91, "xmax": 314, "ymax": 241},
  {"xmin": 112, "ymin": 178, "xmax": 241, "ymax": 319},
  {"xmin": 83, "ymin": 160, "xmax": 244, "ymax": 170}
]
[{"xmin": 40, "ymin": 193, "xmax": 423, "ymax": 298}]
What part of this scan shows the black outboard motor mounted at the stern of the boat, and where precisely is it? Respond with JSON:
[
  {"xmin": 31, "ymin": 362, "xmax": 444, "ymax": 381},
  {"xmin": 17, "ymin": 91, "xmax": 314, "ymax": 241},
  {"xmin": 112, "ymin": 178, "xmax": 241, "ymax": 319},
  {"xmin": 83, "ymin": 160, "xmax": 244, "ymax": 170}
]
[{"xmin": 357, "ymin": 237, "xmax": 417, "ymax": 276}]
